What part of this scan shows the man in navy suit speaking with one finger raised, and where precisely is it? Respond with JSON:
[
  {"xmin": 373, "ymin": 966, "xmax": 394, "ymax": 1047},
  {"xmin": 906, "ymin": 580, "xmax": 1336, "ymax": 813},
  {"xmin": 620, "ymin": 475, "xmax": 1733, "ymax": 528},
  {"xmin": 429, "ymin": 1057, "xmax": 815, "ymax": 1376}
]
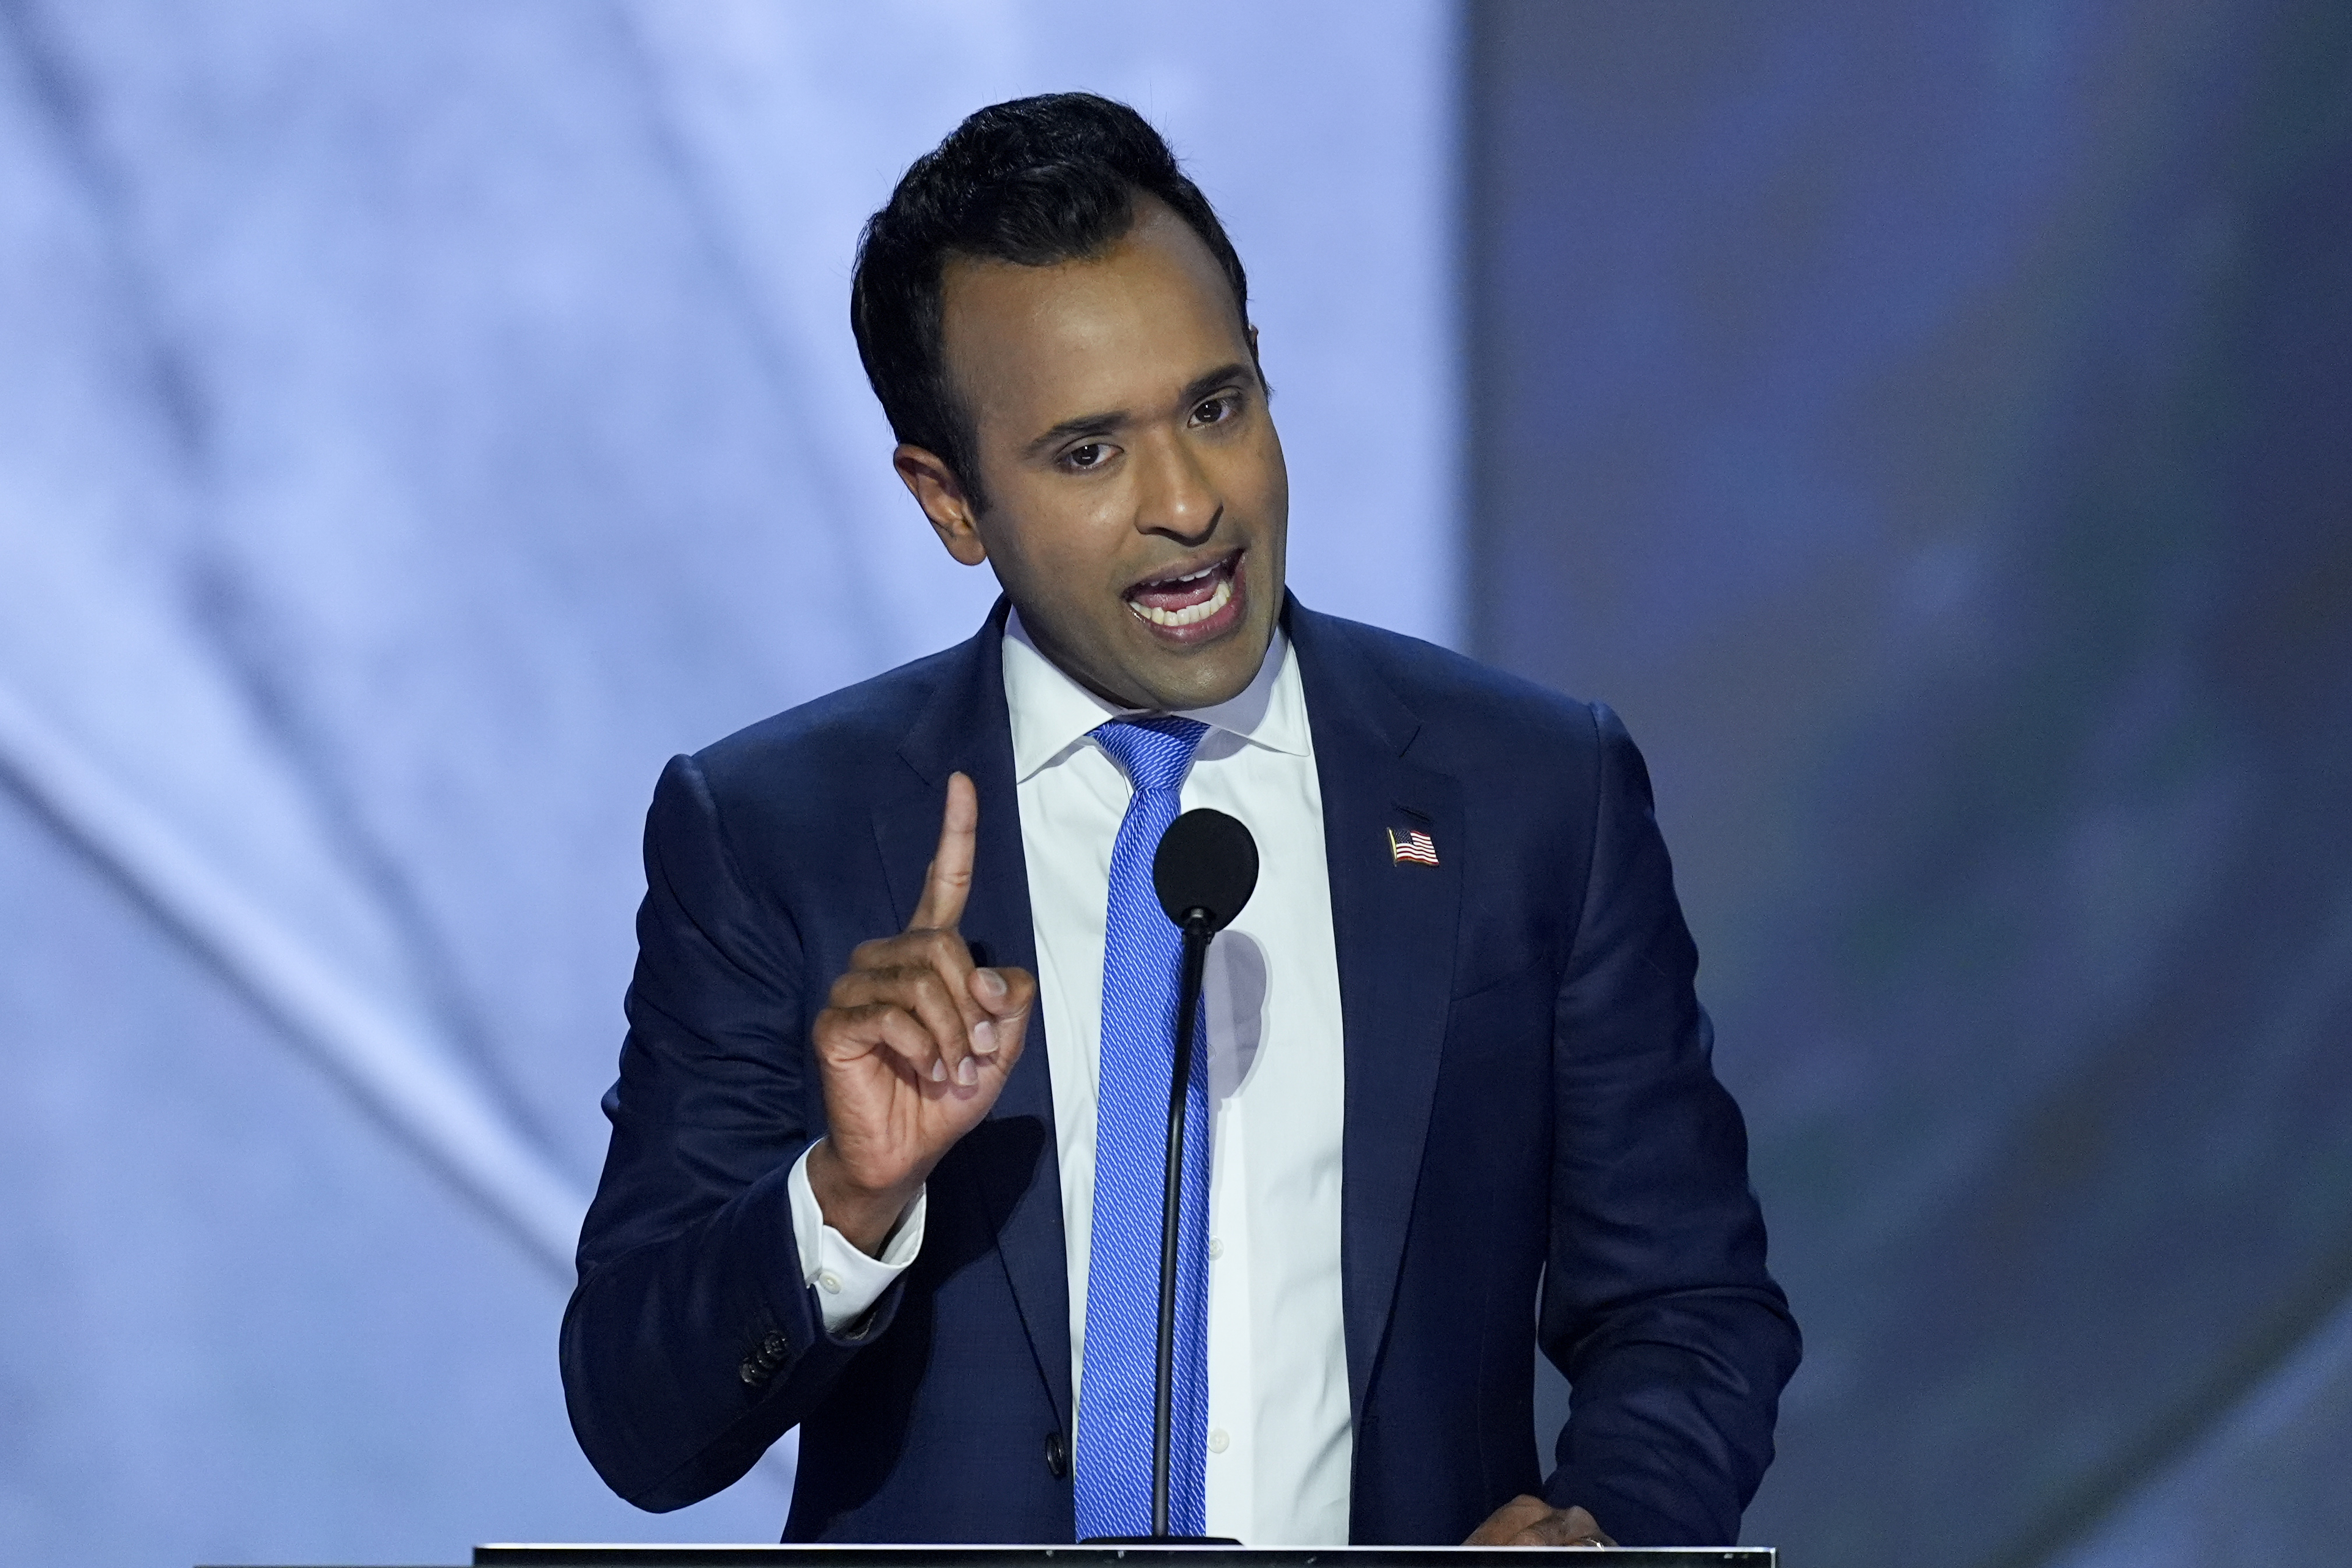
[{"xmin": 562, "ymin": 94, "xmax": 1797, "ymax": 1544}]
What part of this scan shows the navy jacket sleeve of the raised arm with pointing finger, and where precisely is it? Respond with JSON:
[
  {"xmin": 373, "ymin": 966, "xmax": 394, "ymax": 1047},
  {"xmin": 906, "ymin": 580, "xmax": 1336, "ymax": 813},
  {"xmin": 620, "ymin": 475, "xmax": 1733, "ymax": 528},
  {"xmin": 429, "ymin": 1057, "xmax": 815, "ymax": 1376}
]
[{"xmin": 562, "ymin": 757, "xmax": 901, "ymax": 1512}]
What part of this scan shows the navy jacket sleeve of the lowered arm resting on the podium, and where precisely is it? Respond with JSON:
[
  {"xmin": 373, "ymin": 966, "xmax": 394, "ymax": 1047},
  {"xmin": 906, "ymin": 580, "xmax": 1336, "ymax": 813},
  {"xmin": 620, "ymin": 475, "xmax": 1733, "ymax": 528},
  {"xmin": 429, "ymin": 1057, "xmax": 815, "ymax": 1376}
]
[{"xmin": 1541, "ymin": 708, "xmax": 1799, "ymax": 1544}]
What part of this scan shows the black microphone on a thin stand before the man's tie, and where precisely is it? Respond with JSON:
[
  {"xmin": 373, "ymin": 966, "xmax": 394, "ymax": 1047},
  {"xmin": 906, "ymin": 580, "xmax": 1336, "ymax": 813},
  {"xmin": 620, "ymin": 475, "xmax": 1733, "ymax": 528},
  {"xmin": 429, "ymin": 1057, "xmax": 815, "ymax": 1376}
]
[{"xmin": 1133, "ymin": 806, "xmax": 1258, "ymax": 1547}]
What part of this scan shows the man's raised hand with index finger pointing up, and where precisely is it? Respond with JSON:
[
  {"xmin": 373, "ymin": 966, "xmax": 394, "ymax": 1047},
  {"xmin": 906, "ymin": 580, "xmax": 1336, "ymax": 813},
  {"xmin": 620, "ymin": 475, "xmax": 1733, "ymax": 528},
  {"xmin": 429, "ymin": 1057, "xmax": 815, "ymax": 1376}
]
[{"xmin": 809, "ymin": 773, "xmax": 1037, "ymax": 1255}]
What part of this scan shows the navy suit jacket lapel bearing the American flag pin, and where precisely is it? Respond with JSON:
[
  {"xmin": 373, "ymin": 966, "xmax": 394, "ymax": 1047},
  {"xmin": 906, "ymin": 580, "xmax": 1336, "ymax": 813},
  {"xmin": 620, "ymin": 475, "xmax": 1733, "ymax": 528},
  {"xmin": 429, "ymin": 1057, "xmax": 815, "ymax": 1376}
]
[{"xmin": 1286, "ymin": 600, "xmax": 1463, "ymax": 1418}]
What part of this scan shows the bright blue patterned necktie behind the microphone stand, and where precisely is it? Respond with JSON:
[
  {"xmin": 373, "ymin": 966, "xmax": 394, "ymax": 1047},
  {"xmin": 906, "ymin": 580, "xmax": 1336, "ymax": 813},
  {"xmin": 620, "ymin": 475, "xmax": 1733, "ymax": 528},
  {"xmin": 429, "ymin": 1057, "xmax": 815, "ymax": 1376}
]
[{"xmin": 1077, "ymin": 717, "xmax": 1211, "ymax": 1540}]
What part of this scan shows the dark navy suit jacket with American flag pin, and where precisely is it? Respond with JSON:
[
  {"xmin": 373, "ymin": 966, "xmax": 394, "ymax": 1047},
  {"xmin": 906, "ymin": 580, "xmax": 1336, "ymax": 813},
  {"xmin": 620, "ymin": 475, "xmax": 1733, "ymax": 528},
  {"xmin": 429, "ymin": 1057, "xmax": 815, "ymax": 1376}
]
[{"xmin": 562, "ymin": 602, "xmax": 1797, "ymax": 1544}]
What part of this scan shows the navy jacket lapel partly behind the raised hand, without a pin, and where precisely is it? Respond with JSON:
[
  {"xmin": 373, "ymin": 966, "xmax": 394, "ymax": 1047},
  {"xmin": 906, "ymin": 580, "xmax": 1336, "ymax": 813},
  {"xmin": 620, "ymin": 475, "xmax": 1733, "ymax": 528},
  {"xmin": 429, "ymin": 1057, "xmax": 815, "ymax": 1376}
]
[{"xmin": 875, "ymin": 600, "xmax": 1070, "ymax": 1422}]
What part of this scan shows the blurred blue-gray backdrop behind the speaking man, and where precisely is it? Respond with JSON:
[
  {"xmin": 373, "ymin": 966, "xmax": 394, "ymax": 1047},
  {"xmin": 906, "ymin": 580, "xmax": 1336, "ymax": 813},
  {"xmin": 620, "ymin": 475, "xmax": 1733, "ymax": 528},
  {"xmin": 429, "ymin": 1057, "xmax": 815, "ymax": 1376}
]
[{"xmin": 0, "ymin": 0, "xmax": 2352, "ymax": 1568}]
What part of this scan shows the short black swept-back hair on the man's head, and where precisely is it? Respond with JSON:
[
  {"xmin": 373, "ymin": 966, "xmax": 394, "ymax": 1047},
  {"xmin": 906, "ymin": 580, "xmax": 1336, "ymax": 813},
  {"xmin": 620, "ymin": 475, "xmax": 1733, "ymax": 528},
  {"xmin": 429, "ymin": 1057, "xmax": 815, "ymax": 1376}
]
[{"xmin": 849, "ymin": 92, "xmax": 1249, "ymax": 510}]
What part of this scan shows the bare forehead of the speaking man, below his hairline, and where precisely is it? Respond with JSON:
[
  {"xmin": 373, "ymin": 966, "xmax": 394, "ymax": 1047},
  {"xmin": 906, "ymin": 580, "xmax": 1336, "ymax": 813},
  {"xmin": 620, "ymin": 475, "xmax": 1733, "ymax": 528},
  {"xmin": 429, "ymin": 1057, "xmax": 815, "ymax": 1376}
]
[{"xmin": 941, "ymin": 197, "xmax": 1249, "ymax": 430}]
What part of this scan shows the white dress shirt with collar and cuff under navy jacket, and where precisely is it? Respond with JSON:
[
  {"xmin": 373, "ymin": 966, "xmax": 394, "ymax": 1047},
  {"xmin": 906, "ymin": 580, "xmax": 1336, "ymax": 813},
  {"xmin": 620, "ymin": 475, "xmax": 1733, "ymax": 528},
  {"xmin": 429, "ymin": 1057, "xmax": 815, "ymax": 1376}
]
[{"xmin": 790, "ymin": 616, "xmax": 1352, "ymax": 1547}]
